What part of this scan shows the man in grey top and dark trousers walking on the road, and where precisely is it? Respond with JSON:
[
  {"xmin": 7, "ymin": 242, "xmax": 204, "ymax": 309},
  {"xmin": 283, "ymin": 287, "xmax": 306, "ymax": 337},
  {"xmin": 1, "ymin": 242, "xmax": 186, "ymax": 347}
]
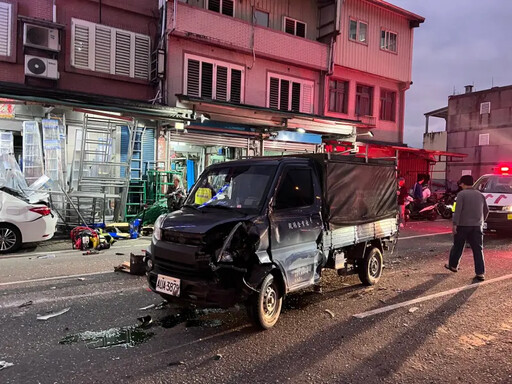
[{"xmin": 445, "ymin": 175, "xmax": 489, "ymax": 281}]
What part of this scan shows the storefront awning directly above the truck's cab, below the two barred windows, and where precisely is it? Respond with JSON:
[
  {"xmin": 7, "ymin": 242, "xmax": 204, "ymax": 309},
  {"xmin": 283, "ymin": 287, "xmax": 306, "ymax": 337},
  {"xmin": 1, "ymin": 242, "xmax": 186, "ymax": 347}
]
[{"xmin": 177, "ymin": 95, "xmax": 361, "ymax": 142}]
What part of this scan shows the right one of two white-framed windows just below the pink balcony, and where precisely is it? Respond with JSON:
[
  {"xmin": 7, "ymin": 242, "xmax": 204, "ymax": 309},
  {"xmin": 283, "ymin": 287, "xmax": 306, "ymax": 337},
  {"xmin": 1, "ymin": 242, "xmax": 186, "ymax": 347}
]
[{"xmin": 267, "ymin": 73, "xmax": 314, "ymax": 113}]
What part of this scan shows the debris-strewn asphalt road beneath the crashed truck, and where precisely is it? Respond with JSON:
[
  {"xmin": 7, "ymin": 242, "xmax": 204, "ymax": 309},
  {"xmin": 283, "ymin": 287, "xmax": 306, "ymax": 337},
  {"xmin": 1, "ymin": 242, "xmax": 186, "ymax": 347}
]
[{"xmin": 0, "ymin": 222, "xmax": 512, "ymax": 384}]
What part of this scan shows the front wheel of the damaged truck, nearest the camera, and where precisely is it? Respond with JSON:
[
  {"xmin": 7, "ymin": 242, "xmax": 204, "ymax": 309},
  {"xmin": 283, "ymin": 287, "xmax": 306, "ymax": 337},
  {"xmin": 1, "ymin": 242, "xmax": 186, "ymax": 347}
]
[{"xmin": 247, "ymin": 275, "xmax": 283, "ymax": 329}]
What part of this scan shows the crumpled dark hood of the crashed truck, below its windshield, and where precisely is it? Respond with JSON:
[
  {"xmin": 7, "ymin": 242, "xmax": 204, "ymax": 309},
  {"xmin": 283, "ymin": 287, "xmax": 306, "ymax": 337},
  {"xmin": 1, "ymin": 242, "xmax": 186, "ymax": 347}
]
[{"xmin": 162, "ymin": 208, "xmax": 256, "ymax": 234}]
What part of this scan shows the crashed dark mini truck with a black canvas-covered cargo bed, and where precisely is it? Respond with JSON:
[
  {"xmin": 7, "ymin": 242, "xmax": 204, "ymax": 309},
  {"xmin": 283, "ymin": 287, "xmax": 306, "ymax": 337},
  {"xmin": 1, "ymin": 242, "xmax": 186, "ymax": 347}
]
[{"xmin": 146, "ymin": 154, "xmax": 398, "ymax": 329}]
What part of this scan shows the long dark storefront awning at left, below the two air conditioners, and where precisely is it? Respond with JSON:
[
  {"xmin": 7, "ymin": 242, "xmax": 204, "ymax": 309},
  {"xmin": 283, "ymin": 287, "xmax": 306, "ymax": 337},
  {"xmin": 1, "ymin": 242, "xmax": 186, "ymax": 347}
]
[{"xmin": 0, "ymin": 82, "xmax": 196, "ymax": 121}]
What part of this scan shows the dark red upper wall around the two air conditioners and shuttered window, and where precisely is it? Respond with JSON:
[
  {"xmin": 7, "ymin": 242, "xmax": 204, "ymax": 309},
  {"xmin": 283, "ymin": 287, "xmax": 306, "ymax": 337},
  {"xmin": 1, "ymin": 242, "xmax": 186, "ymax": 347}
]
[{"xmin": 0, "ymin": 0, "xmax": 158, "ymax": 101}]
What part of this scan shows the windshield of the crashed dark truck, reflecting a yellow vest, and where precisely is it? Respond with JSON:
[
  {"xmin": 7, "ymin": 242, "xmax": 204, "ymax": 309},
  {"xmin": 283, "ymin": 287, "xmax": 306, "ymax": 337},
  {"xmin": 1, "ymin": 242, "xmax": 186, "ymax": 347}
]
[{"xmin": 185, "ymin": 164, "xmax": 276, "ymax": 213}]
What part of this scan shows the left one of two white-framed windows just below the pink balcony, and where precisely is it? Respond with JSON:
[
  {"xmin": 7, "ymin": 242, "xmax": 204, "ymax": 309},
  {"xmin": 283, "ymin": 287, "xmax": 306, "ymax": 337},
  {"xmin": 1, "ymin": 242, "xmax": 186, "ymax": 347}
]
[{"xmin": 184, "ymin": 55, "xmax": 244, "ymax": 103}]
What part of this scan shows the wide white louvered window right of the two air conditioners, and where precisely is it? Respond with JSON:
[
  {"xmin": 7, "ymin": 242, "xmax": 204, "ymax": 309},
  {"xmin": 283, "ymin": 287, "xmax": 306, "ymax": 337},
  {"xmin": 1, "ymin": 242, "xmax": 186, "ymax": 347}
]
[{"xmin": 71, "ymin": 19, "xmax": 151, "ymax": 80}]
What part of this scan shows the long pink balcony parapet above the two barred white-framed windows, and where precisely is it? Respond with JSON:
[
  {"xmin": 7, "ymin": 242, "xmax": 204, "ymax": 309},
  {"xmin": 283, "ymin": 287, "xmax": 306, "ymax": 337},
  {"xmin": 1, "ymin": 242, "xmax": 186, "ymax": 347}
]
[{"xmin": 169, "ymin": 2, "xmax": 329, "ymax": 70}]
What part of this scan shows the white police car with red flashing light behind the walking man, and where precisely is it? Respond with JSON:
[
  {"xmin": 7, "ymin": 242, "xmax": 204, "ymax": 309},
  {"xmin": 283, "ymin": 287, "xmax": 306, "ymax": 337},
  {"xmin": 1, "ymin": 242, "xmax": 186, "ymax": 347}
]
[{"xmin": 474, "ymin": 166, "xmax": 512, "ymax": 232}]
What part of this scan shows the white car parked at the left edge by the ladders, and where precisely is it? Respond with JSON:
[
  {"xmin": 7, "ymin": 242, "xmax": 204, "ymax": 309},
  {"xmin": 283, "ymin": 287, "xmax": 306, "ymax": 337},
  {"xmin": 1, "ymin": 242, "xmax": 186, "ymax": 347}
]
[{"xmin": 0, "ymin": 187, "xmax": 57, "ymax": 253}]
